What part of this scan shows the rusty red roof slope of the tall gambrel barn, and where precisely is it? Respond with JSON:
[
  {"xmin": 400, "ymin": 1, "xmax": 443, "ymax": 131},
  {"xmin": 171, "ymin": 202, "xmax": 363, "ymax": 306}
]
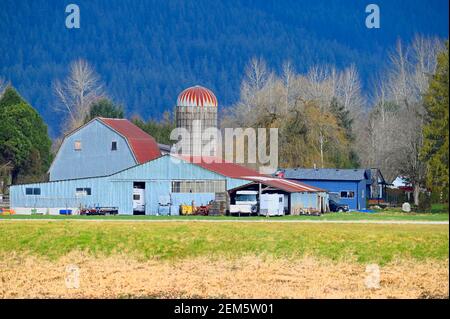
[{"xmin": 98, "ymin": 117, "xmax": 161, "ymax": 164}]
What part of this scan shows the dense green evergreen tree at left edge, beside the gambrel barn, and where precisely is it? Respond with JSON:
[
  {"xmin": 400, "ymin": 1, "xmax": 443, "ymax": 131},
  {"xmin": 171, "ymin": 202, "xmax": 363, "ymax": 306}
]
[{"xmin": 0, "ymin": 87, "xmax": 51, "ymax": 182}]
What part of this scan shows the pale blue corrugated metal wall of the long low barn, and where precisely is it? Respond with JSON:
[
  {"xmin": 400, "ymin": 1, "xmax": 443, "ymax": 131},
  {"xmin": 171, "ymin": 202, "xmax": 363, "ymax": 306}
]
[{"xmin": 10, "ymin": 155, "xmax": 248, "ymax": 214}]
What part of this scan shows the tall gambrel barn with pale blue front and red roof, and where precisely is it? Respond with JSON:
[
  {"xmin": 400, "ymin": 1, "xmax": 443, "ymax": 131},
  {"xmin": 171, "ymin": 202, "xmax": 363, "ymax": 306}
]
[{"xmin": 49, "ymin": 117, "xmax": 161, "ymax": 181}]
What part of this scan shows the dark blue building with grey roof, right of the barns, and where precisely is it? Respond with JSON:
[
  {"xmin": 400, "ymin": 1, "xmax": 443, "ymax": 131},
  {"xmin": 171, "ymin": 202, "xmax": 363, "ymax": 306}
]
[{"xmin": 281, "ymin": 168, "xmax": 386, "ymax": 210}]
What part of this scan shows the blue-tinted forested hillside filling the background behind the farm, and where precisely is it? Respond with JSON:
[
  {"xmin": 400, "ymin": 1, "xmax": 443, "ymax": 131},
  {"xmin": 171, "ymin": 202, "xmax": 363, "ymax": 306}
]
[{"xmin": 0, "ymin": 0, "xmax": 448, "ymax": 136}]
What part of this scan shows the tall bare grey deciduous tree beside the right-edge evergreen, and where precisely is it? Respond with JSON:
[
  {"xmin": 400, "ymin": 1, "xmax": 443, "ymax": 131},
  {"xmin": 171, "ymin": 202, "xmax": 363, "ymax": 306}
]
[{"xmin": 359, "ymin": 36, "xmax": 443, "ymax": 205}]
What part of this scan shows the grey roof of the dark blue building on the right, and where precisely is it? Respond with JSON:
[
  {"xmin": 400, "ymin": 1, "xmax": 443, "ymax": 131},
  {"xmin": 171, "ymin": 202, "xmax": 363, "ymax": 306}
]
[{"xmin": 284, "ymin": 168, "xmax": 369, "ymax": 181}]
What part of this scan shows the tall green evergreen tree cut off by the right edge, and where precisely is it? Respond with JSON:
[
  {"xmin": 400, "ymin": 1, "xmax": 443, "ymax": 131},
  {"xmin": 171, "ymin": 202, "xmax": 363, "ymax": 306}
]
[{"xmin": 421, "ymin": 42, "xmax": 449, "ymax": 200}]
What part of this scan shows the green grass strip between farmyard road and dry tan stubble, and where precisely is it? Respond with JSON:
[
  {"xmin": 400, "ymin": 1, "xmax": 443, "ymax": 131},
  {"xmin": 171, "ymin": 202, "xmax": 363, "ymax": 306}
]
[{"xmin": 0, "ymin": 221, "xmax": 449, "ymax": 265}]
